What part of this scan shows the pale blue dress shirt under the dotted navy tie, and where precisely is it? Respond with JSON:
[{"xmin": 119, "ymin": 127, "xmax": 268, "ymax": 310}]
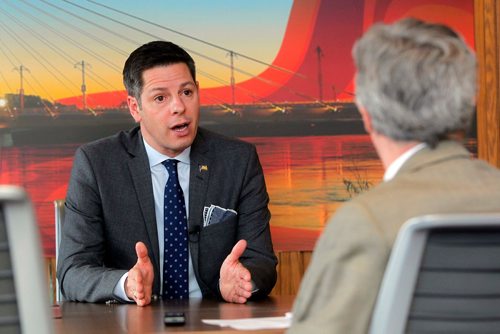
[{"xmin": 114, "ymin": 140, "xmax": 202, "ymax": 301}]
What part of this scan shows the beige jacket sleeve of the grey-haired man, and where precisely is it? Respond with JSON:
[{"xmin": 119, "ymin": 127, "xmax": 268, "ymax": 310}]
[{"xmin": 288, "ymin": 202, "xmax": 390, "ymax": 334}]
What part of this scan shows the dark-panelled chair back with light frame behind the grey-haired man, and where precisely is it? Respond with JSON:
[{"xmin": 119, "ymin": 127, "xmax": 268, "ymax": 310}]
[{"xmin": 370, "ymin": 213, "xmax": 500, "ymax": 334}]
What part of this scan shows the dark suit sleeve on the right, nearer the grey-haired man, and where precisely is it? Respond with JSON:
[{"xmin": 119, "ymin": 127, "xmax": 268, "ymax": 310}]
[{"xmin": 234, "ymin": 146, "xmax": 277, "ymax": 298}]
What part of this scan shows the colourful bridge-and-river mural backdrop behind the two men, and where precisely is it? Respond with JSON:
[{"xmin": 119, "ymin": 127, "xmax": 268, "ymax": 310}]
[{"xmin": 0, "ymin": 0, "xmax": 476, "ymax": 257}]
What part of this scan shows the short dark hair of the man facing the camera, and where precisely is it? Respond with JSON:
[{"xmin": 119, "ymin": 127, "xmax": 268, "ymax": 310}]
[{"xmin": 123, "ymin": 41, "xmax": 196, "ymax": 106}]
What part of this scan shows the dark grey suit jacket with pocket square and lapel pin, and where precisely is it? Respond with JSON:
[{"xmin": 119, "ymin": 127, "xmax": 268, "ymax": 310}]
[{"xmin": 57, "ymin": 128, "xmax": 277, "ymax": 302}]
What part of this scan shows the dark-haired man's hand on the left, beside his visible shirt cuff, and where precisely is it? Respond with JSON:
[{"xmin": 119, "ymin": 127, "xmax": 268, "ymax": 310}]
[{"xmin": 125, "ymin": 241, "xmax": 154, "ymax": 306}]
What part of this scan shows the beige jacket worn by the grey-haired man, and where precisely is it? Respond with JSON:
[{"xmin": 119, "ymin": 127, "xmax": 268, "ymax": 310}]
[{"xmin": 289, "ymin": 141, "xmax": 500, "ymax": 334}]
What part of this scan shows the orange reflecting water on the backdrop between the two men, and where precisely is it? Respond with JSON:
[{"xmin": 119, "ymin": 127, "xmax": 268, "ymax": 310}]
[{"xmin": 246, "ymin": 135, "xmax": 383, "ymax": 231}]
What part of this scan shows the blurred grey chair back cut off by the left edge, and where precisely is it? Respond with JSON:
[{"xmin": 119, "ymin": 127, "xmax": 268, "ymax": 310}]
[{"xmin": 0, "ymin": 186, "xmax": 53, "ymax": 333}]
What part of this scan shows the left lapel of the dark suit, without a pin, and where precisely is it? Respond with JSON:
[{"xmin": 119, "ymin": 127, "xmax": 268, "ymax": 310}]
[{"xmin": 125, "ymin": 132, "xmax": 160, "ymax": 276}]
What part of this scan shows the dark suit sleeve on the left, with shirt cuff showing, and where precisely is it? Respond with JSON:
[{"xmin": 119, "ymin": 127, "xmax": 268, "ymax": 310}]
[{"xmin": 57, "ymin": 148, "xmax": 126, "ymax": 302}]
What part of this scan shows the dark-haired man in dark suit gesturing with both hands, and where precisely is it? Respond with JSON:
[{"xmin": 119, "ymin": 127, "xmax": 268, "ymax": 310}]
[{"xmin": 57, "ymin": 41, "xmax": 277, "ymax": 306}]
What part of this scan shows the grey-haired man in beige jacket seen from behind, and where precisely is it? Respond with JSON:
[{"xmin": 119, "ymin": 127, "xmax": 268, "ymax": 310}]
[{"xmin": 289, "ymin": 19, "xmax": 500, "ymax": 334}]
